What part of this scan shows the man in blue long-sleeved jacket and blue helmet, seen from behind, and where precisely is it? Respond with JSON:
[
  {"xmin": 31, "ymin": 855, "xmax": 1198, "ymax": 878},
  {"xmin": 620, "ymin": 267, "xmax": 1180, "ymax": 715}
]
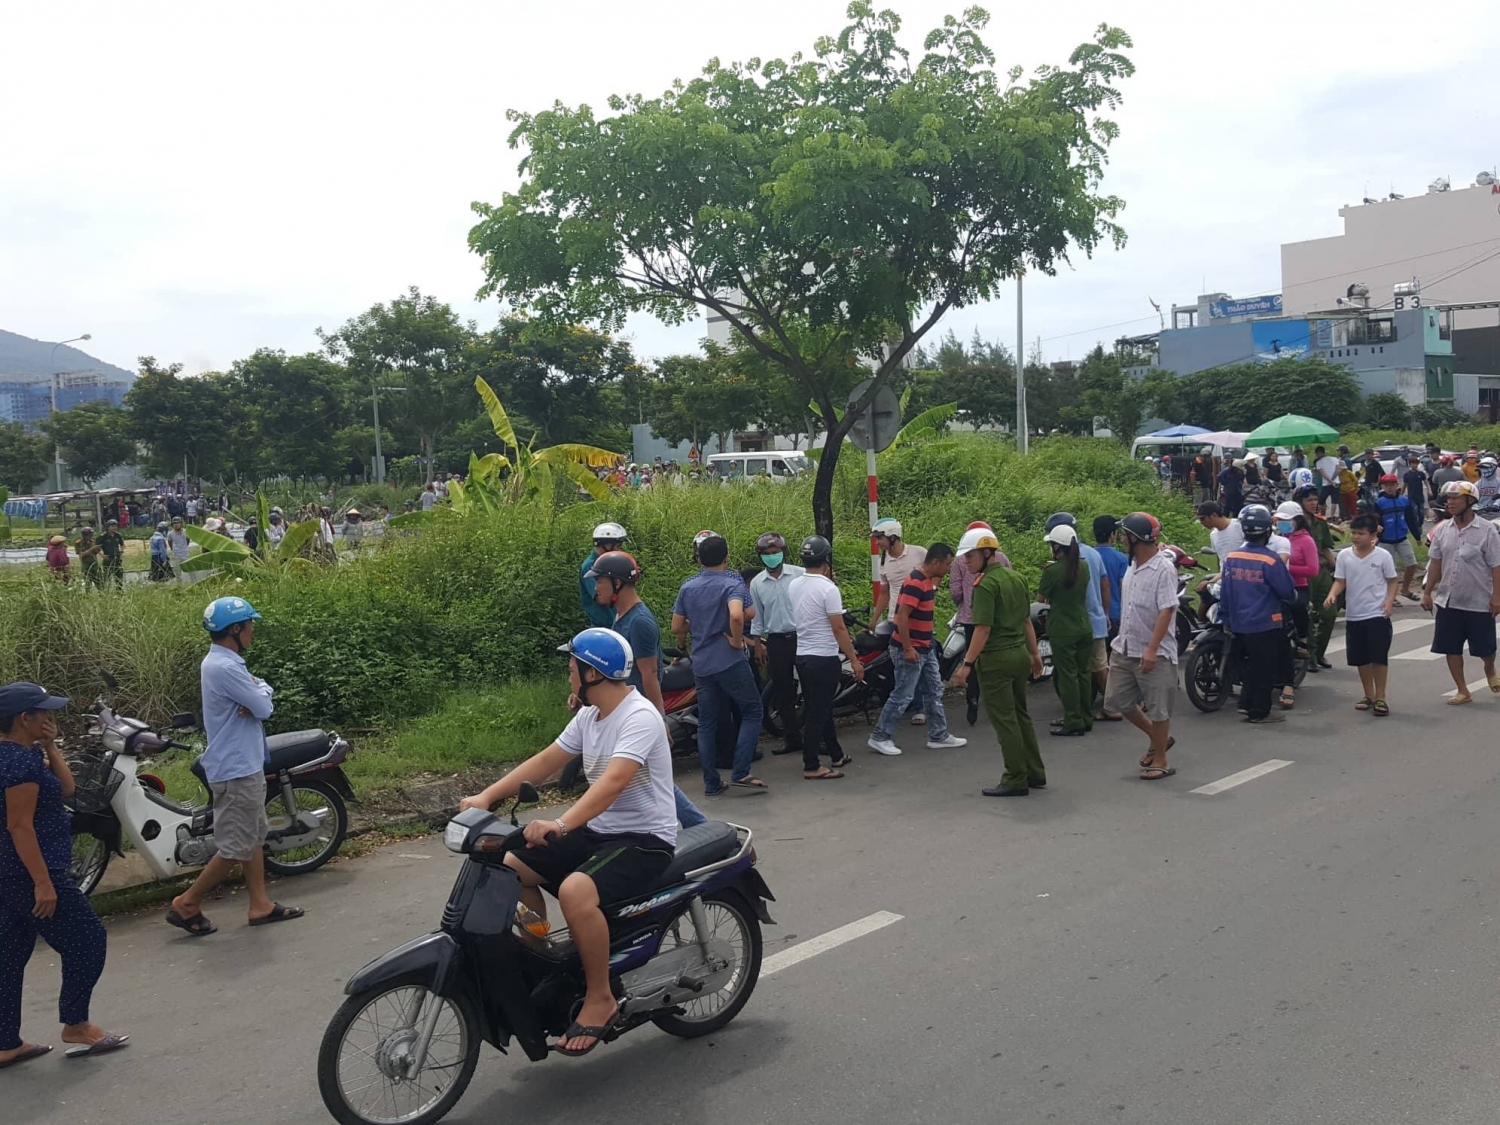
[{"xmin": 1220, "ymin": 504, "xmax": 1298, "ymax": 723}]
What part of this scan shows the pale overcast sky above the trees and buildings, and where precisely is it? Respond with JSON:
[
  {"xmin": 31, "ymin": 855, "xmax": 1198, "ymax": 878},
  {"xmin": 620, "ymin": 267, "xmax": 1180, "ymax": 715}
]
[{"xmin": 0, "ymin": 0, "xmax": 1500, "ymax": 381}]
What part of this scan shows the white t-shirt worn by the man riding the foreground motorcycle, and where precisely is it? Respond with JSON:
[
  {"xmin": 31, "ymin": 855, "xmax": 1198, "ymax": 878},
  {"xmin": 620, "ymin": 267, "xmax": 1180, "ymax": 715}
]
[{"xmin": 558, "ymin": 692, "xmax": 677, "ymax": 845}]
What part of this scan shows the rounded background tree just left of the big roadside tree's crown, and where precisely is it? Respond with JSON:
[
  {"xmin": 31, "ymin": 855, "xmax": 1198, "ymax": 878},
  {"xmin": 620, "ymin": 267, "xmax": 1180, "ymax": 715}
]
[{"xmin": 318, "ymin": 287, "xmax": 476, "ymax": 480}]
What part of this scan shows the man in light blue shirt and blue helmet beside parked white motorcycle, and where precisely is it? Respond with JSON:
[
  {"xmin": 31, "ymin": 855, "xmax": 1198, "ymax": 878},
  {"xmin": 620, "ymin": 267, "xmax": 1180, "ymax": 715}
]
[{"xmin": 167, "ymin": 597, "xmax": 303, "ymax": 938}]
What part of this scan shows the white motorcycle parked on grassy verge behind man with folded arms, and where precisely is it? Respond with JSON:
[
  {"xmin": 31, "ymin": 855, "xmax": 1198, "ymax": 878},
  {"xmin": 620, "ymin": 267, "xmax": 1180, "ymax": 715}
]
[{"xmin": 68, "ymin": 699, "xmax": 357, "ymax": 894}]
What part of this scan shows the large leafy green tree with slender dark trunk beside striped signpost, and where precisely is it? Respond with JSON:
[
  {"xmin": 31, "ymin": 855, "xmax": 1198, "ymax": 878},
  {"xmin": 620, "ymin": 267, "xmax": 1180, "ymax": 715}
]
[{"xmin": 470, "ymin": 0, "xmax": 1133, "ymax": 534}]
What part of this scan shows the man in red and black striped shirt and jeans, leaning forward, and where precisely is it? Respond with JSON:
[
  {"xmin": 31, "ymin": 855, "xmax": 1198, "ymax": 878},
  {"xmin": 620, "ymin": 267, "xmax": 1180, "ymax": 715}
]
[{"xmin": 869, "ymin": 543, "xmax": 969, "ymax": 758}]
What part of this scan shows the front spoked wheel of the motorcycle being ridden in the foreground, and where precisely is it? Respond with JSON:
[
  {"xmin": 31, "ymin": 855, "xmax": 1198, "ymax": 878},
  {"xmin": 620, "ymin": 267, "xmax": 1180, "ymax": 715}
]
[{"xmin": 318, "ymin": 984, "xmax": 480, "ymax": 1125}]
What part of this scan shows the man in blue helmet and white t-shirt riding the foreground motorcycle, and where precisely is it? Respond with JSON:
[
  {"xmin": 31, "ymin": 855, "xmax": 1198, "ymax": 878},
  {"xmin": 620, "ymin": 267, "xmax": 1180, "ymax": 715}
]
[{"xmin": 459, "ymin": 629, "xmax": 677, "ymax": 1056}]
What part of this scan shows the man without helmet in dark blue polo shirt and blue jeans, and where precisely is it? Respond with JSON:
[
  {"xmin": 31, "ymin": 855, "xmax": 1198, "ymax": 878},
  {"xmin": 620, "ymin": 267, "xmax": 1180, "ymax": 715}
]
[{"xmin": 672, "ymin": 531, "xmax": 767, "ymax": 797}]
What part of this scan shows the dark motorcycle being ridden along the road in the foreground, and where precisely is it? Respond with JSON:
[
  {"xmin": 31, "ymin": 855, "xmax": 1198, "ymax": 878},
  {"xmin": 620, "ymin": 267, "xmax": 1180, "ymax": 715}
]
[{"xmin": 318, "ymin": 785, "xmax": 774, "ymax": 1125}]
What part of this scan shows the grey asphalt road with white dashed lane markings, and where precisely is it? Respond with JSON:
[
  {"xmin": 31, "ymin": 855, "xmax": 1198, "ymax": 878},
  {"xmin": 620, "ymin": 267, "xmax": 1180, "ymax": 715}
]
[{"xmin": 11, "ymin": 609, "xmax": 1500, "ymax": 1125}]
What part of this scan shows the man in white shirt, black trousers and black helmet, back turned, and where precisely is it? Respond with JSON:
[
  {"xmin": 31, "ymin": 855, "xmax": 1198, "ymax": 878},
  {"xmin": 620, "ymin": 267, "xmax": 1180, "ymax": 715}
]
[{"xmin": 792, "ymin": 536, "xmax": 864, "ymax": 782}]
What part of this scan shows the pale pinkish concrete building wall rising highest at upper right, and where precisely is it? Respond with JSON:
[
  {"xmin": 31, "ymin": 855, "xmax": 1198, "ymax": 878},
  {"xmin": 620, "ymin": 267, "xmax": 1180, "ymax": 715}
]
[{"xmin": 1281, "ymin": 186, "xmax": 1500, "ymax": 319}]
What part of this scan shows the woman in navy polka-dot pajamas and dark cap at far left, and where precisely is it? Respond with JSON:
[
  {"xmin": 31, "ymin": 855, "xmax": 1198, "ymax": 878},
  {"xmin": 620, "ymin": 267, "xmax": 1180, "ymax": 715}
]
[{"xmin": 0, "ymin": 683, "xmax": 131, "ymax": 1068}]
